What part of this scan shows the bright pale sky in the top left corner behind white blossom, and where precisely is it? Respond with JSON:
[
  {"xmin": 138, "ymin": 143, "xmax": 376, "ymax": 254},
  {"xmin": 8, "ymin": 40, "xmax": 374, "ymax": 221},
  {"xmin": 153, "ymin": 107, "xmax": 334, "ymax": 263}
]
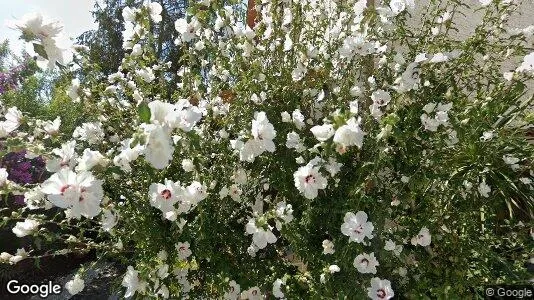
[{"xmin": 0, "ymin": 0, "xmax": 96, "ymax": 51}]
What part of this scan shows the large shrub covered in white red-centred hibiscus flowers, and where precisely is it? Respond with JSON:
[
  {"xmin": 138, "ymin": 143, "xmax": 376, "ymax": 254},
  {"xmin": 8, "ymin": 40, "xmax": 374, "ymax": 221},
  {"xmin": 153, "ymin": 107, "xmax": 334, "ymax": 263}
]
[{"xmin": 0, "ymin": 0, "xmax": 534, "ymax": 299}]
